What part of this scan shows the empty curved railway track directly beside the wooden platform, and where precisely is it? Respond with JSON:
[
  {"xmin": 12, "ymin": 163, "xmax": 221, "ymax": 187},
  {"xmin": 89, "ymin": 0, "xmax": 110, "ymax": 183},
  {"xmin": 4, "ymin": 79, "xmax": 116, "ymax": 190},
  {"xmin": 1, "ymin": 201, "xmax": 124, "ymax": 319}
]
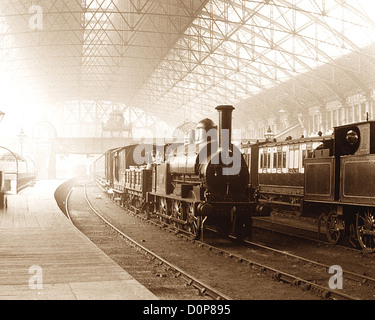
[{"xmin": 65, "ymin": 181, "xmax": 230, "ymax": 300}]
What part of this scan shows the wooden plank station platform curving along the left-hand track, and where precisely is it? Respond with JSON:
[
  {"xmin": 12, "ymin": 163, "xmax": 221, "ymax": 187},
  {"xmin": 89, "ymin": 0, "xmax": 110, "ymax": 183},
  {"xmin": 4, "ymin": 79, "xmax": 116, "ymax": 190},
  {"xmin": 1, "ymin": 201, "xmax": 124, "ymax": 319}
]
[{"xmin": 0, "ymin": 181, "xmax": 157, "ymax": 300}]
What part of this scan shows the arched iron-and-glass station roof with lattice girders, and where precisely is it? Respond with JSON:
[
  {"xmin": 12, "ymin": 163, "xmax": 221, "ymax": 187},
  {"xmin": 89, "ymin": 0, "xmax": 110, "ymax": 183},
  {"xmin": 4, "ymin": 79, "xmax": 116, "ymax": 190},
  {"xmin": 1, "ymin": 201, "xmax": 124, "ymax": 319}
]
[{"xmin": 0, "ymin": 0, "xmax": 375, "ymax": 128}]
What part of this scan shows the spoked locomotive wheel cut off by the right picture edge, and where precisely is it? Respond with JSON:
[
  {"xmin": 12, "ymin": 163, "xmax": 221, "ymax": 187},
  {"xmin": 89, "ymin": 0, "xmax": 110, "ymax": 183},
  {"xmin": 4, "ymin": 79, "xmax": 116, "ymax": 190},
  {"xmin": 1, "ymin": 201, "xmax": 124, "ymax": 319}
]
[{"xmin": 356, "ymin": 208, "xmax": 375, "ymax": 252}]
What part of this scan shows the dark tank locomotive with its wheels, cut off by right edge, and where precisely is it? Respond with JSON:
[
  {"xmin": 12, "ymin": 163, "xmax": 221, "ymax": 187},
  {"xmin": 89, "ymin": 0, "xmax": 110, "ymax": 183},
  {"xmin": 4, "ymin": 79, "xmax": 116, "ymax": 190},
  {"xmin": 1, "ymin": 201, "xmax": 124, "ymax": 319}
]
[{"xmin": 305, "ymin": 121, "xmax": 375, "ymax": 251}]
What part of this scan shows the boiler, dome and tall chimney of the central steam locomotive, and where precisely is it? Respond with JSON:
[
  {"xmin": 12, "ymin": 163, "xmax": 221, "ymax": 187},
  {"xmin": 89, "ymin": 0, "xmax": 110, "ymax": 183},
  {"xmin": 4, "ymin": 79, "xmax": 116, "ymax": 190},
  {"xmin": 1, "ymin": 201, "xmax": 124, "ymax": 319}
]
[{"xmin": 168, "ymin": 106, "xmax": 249, "ymax": 201}]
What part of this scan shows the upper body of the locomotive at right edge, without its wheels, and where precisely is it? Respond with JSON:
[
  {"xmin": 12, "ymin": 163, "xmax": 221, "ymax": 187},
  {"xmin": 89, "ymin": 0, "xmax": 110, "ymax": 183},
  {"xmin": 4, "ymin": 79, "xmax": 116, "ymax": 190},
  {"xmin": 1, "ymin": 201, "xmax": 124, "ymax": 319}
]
[{"xmin": 305, "ymin": 121, "xmax": 375, "ymax": 203}]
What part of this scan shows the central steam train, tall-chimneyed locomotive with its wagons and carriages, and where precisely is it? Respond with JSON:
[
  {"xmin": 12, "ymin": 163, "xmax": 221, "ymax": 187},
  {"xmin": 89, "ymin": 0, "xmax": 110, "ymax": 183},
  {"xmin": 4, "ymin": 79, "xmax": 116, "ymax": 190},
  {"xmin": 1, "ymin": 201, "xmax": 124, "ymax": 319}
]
[{"xmin": 93, "ymin": 105, "xmax": 255, "ymax": 238}]
